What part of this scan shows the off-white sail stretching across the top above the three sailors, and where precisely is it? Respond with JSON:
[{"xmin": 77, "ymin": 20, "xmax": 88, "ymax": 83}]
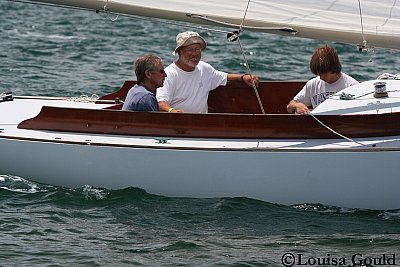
[{"xmin": 27, "ymin": 0, "xmax": 400, "ymax": 49}]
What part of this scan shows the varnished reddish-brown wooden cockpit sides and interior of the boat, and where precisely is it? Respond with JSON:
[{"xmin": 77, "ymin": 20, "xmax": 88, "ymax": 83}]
[{"xmin": 18, "ymin": 81, "xmax": 400, "ymax": 139}]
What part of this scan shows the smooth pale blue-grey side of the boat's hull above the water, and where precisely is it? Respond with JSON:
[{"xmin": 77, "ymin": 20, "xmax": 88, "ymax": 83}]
[{"xmin": 0, "ymin": 134, "xmax": 400, "ymax": 209}]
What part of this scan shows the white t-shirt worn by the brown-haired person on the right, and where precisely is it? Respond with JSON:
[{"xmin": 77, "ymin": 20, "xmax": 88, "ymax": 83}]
[{"xmin": 293, "ymin": 72, "xmax": 358, "ymax": 108}]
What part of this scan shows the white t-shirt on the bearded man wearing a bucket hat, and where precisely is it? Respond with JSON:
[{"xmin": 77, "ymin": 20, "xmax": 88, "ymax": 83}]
[{"xmin": 157, "ymin": 61, "xmax": 228, "ymax": 113}]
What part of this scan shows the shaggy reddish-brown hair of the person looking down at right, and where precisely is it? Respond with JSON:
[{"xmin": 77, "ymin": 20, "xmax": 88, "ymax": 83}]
[{"xmin": 310, "ymin": 45, "xmax": 342, "ymax": 75}]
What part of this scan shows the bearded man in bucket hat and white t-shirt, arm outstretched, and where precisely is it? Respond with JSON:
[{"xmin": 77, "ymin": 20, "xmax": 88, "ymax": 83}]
[{"xmin": 157, "ymin": 31, "xmax": 259, "ymax": 113}]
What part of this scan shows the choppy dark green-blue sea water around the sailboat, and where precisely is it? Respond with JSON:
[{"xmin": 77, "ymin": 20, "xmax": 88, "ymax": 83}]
[{"xmin": 0, "ymin": 0, "xmax": 400, "ymax": 266}]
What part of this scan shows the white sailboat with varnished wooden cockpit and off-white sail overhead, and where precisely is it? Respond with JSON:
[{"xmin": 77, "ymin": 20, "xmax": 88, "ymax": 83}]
[{"xmin": 0, "ymin": 0, "xmax": 400, "ymax": 210}]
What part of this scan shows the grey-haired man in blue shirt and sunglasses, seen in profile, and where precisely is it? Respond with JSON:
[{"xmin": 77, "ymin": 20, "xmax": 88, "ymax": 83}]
[{"xmin": 122, "ymin": 55, "xmax": 167, "ymax": 111}]
